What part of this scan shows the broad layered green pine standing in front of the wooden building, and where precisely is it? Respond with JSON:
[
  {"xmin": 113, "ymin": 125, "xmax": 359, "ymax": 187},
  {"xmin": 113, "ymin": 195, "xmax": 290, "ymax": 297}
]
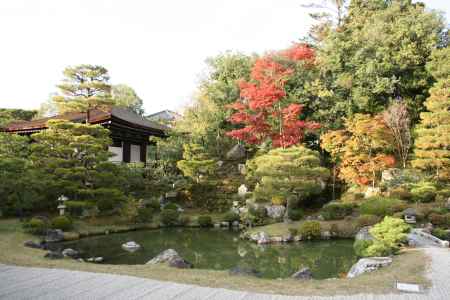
[{"xmin": 30, "ymin": 120, "xmax": 124, "ymax": 210}]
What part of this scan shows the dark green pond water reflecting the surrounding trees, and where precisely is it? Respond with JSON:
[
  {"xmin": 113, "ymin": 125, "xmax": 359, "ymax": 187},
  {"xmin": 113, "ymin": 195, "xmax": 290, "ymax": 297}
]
[{"xmin": 61, "ymin": 228, "xmax": 356, "ymax": 279}]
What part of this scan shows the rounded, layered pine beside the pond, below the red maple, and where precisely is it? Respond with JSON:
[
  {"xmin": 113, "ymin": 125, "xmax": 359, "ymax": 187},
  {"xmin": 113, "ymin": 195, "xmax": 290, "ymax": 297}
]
[{"xmin": 251, "ymin": 146, "xmax": 329, "ymax": 203}]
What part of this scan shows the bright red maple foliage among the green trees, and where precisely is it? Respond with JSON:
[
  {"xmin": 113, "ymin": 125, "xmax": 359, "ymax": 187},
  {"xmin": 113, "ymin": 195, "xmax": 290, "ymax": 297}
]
[{"xmin": 227, "ymin": 44, "xmax": 319, "ymax": 148}]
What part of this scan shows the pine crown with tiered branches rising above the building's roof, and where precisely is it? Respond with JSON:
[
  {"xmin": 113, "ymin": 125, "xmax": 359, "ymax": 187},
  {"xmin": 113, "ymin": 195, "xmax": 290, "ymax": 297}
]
[{"xmin": 53, "ymin": 65, "xmax": 114, "ymax": 117}]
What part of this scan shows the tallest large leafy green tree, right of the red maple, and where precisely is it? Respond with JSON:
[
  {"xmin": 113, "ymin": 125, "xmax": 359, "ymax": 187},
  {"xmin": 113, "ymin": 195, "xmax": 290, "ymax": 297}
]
[{"xmin": 318, "ymin": 0, "xmax": 445, "ymax": 123}]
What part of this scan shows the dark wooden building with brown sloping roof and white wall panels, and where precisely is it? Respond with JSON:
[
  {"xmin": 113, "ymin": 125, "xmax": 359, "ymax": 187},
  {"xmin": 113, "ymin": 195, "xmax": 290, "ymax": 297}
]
[{"xmin": 4, "ymin": 107, "xmax": 168, "ymax": 163}]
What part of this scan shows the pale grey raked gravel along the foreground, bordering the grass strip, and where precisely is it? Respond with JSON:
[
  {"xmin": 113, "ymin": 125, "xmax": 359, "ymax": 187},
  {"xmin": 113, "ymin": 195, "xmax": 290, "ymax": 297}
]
[{"xmin": 0, "ymin": 248, "xmax": 450, "ymax": 300}]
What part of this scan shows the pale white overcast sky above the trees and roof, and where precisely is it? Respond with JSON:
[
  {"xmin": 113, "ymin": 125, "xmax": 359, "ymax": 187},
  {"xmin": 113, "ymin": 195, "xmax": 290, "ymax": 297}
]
[{"xmin": 0, "ymin": 0, "xmax": 450, "ymax": 113}]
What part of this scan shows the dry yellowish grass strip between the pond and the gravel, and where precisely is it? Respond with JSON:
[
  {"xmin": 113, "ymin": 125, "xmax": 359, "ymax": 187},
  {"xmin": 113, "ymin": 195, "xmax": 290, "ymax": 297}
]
[{"xmin": 0, "ymin": 219, "xmax": 428, "ymax": 295}]
